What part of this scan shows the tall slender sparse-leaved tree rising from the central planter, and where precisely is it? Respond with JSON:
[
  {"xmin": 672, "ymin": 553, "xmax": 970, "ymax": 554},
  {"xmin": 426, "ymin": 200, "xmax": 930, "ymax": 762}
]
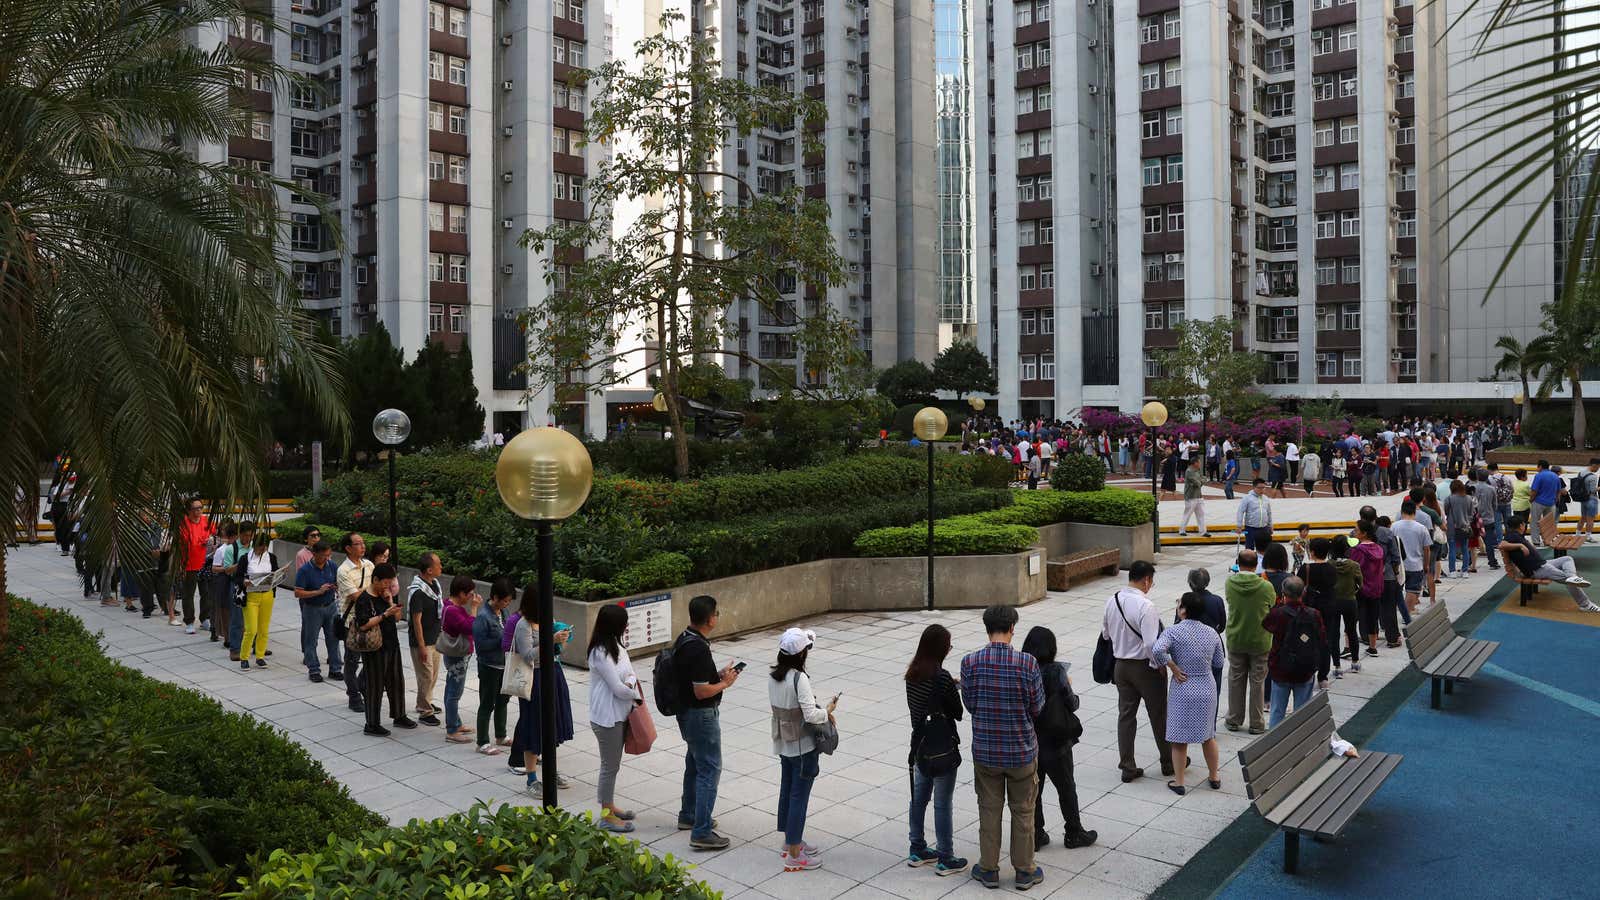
[{"xmin": 523, "ymin": 14, "xmax": 861, "ymax": 477}]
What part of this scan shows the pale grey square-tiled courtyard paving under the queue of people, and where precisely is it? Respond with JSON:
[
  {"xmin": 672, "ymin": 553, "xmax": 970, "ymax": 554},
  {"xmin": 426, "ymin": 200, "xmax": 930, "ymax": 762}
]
[{"xmin": 8, "ymin": 528, "xmax": 1498, "ymax": 900}]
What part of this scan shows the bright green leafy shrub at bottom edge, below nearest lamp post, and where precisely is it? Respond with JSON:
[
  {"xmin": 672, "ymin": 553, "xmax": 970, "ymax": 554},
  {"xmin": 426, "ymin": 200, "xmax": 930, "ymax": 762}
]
[{"xmin": 230, "ymin": 804, "xmax": 717, "ymax": 900}]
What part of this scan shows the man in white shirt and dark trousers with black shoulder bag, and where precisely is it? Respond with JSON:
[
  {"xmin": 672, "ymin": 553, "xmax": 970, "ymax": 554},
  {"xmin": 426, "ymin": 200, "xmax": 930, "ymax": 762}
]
[{"xmin": 1101, "ymin": 559, "xmax": 1173, "ymax": 783}]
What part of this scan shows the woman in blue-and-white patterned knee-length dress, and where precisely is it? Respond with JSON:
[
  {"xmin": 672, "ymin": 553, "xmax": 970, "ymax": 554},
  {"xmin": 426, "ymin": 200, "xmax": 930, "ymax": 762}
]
[{"xmin": 1152, "ymin": 591, "xmax": 1222, "ymax": 796}]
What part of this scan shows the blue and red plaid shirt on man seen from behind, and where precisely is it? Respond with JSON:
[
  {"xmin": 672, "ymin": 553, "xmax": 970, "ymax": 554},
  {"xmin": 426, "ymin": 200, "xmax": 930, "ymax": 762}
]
[{"xmin": 962, "ymin": 644, "xmax": 1045, "ymax": 769}]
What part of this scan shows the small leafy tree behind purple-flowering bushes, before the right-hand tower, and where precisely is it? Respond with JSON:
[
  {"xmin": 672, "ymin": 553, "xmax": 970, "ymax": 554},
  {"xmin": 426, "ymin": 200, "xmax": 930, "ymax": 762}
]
[{"xmin": 1150, "ymin": 315, "xmax": 1266, "ymax": 421}]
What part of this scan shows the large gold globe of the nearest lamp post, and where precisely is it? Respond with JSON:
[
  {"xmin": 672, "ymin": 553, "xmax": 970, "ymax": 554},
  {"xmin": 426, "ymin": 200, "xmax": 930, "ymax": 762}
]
[{"xmin": 494, "ymin": 428, "xmax": 594, "ymax": 522}]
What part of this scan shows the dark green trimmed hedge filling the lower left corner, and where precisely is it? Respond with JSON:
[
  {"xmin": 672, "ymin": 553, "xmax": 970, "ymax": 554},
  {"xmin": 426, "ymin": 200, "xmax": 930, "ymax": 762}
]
[{"xmin": 0, "ymin": 597, "xmax": 382, "ymax": 897}]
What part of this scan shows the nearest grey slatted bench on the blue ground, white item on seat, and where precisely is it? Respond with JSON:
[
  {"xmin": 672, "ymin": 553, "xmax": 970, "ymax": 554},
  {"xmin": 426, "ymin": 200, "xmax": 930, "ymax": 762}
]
[{"xmin": 1238, "ymin": 690, "xmax": 1402, "ymax": 874}]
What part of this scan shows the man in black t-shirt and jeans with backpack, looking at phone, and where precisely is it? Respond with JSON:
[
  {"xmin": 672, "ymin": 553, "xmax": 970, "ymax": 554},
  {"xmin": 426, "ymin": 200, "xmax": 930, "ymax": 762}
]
[{"xmin": 672, "ymin": 594, "xmax": 742, "ymax": 850}]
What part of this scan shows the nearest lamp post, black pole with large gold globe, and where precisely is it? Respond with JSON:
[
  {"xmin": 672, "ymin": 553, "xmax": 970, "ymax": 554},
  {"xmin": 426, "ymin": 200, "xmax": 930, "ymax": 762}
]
[{"xmin": 494, "ymin": 428, "xmax": 594, "ymax": 809}]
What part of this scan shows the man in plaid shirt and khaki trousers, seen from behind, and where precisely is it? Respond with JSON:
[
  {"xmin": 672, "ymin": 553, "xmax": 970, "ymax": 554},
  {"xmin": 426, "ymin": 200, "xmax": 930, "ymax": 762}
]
[{"xmin": 962, "ymin": 602, "xmax": 1049, "ymax": 890}]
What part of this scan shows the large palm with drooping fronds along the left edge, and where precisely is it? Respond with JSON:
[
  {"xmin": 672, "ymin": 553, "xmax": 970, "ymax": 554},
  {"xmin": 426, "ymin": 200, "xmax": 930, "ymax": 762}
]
[{"xmin": 0, "ymin": 0, "xmax": 347, "ymax": 641}]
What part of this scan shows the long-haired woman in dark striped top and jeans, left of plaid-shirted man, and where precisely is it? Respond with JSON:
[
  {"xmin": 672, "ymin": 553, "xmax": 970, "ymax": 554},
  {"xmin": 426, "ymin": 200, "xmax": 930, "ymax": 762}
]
[{"xmin": 906, "ymin": 625, "xmax": 966, "ymax": 876}]
